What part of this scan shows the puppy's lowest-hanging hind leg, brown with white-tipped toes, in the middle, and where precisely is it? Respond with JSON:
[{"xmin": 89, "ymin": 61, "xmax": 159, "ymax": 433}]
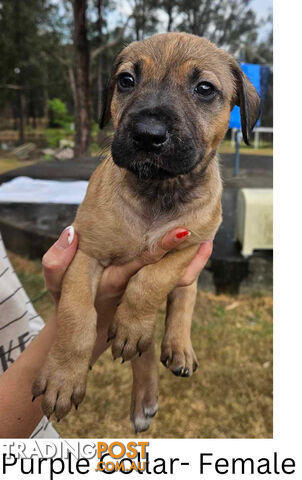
[{"xmin": 130, "ymin": 343, "xmax": 158, "ymax": 433}]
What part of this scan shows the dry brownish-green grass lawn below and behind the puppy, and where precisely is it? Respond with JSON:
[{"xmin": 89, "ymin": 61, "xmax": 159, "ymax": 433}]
[{"xmin": 9, "ymin": 249, "xmax": 273, "ymax": 438}]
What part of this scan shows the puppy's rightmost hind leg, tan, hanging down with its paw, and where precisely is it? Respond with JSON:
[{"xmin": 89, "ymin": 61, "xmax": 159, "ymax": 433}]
[{"xmin": 160, "ymin": 280, "xmax": 198, "ymax": 377}]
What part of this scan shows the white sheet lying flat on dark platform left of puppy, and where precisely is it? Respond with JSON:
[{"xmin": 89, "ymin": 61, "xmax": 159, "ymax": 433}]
[{"xmin": 0, "ymin": 177, "xmax": 88, "ymax": 205}]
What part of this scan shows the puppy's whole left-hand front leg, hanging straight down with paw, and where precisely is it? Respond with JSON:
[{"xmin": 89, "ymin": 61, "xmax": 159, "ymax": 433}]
[{"xmin": 32, "ymin": 250, "xmax": 102, "ymax": 420}]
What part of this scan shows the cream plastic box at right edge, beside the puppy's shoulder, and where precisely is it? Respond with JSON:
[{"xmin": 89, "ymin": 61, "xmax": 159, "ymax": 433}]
[{"xmin": 236, "ymin": 188, "xmax": 273, "ymax": 256}]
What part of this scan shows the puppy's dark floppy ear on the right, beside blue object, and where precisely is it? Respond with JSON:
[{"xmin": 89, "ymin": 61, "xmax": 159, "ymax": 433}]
[{"xmin": 232, "ymin": 61, "xmax": 261, "ymax": 145}]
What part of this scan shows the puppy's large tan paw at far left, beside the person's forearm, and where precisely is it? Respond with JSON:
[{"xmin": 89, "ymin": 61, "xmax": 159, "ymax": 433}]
[{"xmin": 32, "ymin": 355, "xmax": 89, "ymax": 421}]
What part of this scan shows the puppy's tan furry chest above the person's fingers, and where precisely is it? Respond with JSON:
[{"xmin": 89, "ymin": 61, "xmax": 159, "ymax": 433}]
[{"xmin": 75, "ymin": 178, "xmax": 219, "ymax": 266}]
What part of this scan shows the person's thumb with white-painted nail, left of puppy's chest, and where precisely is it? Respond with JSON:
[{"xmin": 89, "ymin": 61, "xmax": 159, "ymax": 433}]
[{"xmin": 42, "ymin": 226, "xmax": 78, "ymax": 296}]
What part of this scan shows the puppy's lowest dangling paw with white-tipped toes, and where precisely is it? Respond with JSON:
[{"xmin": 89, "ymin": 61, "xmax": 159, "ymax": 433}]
[{"xmin": 130, "ymin": 383, "xmax": 158, "ymax": 433}]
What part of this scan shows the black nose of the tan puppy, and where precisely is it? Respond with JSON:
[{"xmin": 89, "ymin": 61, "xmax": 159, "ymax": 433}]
[{"xmin": 132, "ymin": 117, "xmax": 168, "ymax": 148}]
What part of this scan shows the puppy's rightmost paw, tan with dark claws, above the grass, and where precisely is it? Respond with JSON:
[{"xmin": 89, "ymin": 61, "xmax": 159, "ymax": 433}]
[{"xmin": 160, "ymin": 340, "xmax": 198, "ymax": 377}]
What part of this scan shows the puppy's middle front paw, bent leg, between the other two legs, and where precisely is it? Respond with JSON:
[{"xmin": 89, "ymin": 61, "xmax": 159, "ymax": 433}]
[{"xmin": 108, "ymin": 301, "xmax": 155, "ymax": 361}]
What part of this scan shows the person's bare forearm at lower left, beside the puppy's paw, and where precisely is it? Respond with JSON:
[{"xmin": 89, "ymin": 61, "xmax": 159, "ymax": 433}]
[{"xmin": 0, "ymin": 319, "xmax": 56, "ymax": 438}]
